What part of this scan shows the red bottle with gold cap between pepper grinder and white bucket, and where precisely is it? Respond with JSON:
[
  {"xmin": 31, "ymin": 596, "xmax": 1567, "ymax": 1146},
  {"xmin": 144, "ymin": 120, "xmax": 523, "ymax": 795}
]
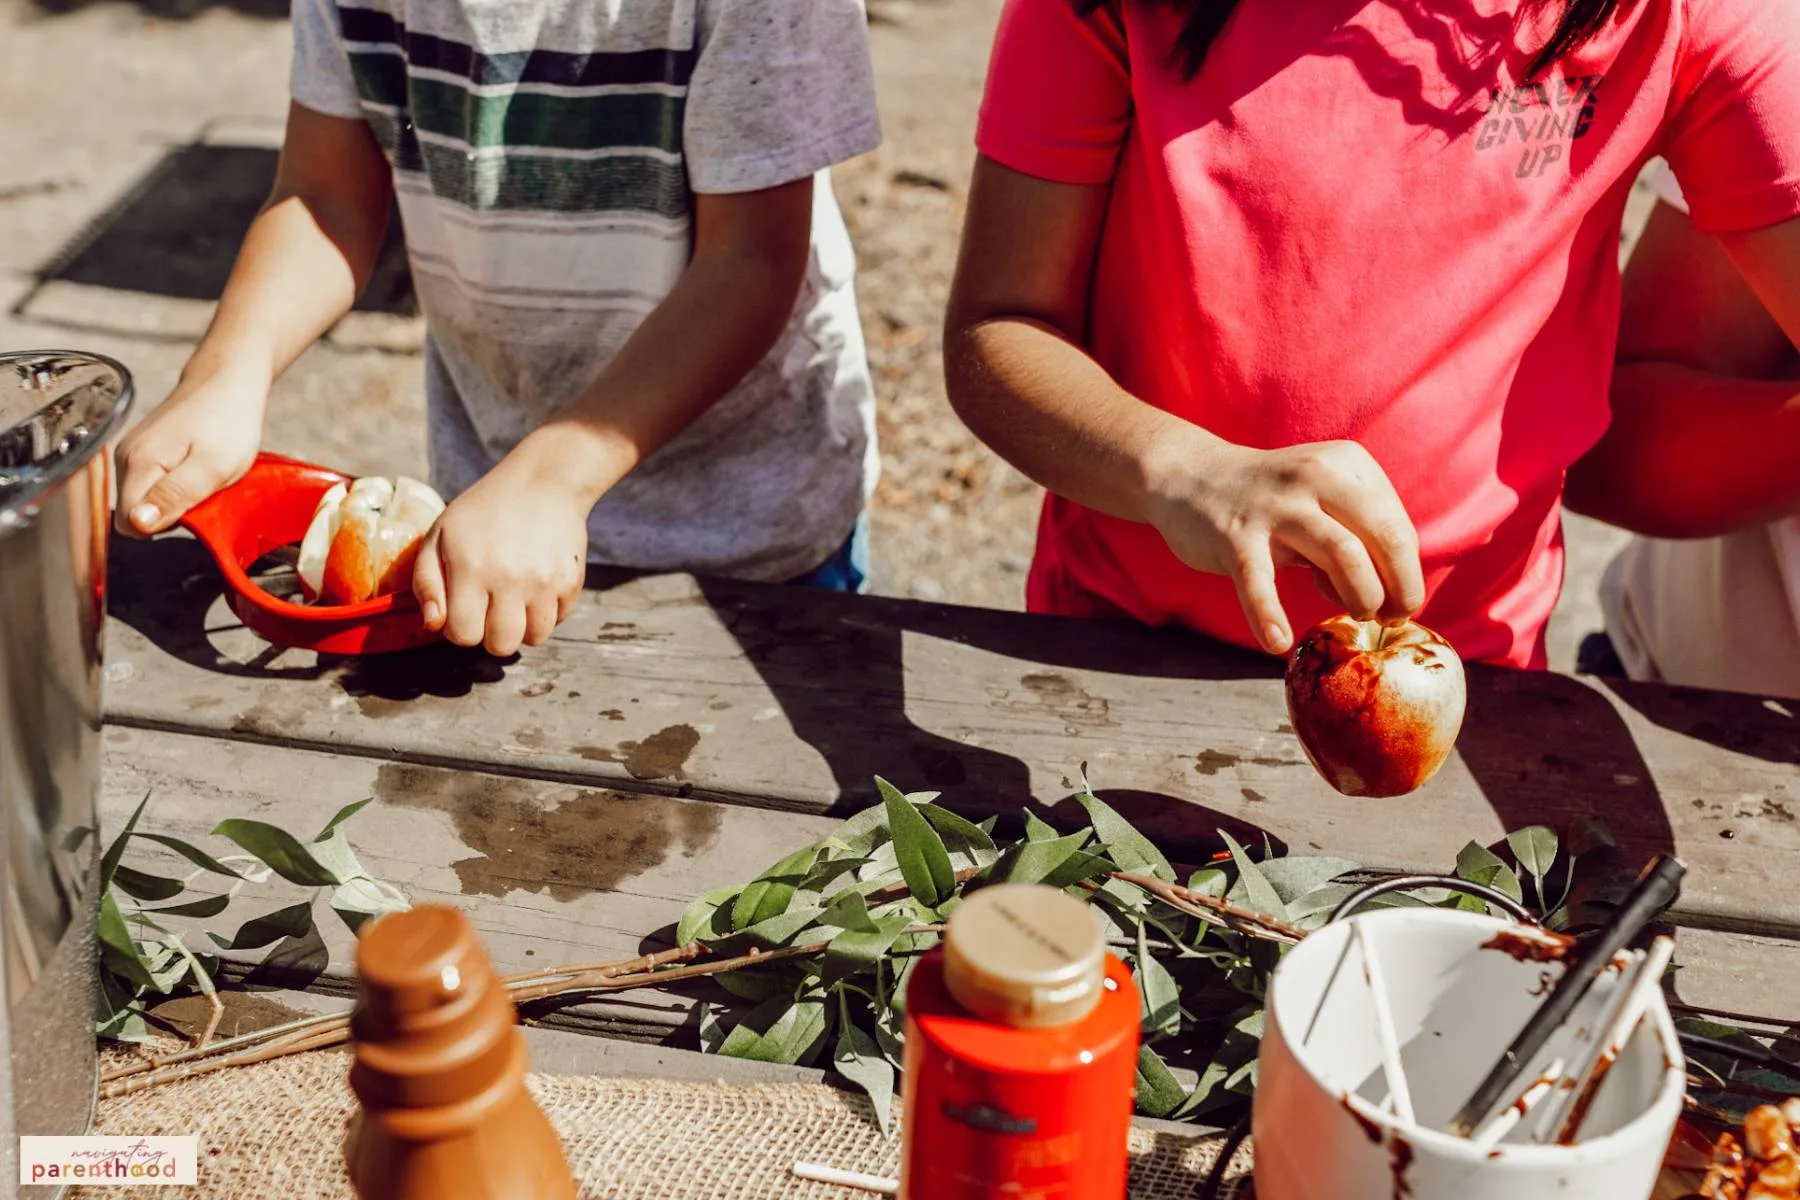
[{"xmin": 900, "ymin": 883, "xmax": 1139, "ymax": 1200}]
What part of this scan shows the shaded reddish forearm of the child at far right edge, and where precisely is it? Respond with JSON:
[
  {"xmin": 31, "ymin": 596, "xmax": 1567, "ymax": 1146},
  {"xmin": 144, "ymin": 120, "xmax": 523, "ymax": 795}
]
[{"xmin": 1566, "ymin": 362, "xmax": 1800, "ymax": 538}]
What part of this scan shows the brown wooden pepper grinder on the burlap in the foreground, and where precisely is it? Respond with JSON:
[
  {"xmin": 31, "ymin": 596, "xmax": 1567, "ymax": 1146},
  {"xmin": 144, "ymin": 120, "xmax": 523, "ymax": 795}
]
[{"xmin": 346, "ymin": 905, "xmax": 576, "ymax": 1200}]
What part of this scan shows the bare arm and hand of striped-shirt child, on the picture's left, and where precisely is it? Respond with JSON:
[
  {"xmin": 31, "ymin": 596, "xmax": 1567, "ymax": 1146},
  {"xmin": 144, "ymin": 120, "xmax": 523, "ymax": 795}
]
[{"xmin": 119, "ymin": 104, "xmax": 392, "ymax": 534}]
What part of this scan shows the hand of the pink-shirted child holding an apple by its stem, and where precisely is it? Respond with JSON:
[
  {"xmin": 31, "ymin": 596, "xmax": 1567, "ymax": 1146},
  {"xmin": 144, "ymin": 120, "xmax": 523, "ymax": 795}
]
[{"xmin": 1154, "ymin": 439, "xmax": 1426, "ymax": 653}]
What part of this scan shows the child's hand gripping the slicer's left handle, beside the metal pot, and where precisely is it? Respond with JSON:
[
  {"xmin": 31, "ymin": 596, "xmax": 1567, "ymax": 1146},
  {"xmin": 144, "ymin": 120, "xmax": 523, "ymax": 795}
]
[{"xmin": 113, "ymin": 374, "xmax": 268, "ymax": 538}]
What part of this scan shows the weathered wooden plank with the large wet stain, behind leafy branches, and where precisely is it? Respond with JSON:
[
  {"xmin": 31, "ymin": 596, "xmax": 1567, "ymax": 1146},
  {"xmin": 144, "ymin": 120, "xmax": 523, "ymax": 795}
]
[{"xmin": 103, "ymin": 729, "xmax": 835, "ymax": 1038}]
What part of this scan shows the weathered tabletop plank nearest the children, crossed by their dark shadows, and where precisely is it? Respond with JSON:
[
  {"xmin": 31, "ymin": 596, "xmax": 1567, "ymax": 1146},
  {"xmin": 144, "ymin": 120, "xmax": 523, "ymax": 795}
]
[{"xmin": 108, "ymin": 540, "xmax": 1800, "ymax": 932}]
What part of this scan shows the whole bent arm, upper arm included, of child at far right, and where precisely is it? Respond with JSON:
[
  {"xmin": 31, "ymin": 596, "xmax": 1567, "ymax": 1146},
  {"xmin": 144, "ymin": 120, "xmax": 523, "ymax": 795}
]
[{"xmin": 1568, "ymin": 203, "xmax": 1800, "ymax": 538}]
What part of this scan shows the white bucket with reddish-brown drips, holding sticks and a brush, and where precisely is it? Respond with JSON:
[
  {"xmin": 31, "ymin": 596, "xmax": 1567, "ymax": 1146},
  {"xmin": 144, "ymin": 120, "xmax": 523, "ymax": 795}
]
[{"xmin": 1251, "ymin": 909, "xmax": 1687, "ymax": 1200}]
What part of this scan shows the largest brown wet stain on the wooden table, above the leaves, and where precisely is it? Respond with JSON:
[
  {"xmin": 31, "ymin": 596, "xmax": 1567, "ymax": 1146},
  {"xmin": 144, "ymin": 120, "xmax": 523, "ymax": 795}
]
[{"xmin": 374, "ymin": 763, "xmax": 722, "ymax": 901}]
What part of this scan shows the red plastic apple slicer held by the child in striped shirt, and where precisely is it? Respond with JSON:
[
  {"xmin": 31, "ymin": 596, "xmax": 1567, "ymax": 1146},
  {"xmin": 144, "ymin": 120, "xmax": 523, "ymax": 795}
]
[{"xmin": 182, "ymin": 453, "xmax": 437, "ymax": 655}]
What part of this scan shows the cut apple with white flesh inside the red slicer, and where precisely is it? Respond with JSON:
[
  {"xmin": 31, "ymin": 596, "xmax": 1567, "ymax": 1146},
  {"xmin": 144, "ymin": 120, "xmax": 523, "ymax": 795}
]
[{"xmin": 299, "ymin": 475, "xmax": 445, "ymax": 604}]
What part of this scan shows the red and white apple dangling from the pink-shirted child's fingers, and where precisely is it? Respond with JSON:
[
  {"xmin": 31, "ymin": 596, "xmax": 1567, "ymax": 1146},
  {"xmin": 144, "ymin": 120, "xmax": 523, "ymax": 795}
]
[{"xmin": 1287, "ymin": 615, "xmax": 1467, "ymax": 797}]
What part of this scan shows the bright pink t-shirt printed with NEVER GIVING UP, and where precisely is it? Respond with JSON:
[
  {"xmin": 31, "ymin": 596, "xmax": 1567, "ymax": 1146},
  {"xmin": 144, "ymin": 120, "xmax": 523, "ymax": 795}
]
[{"xmin": 977, "ymin": 0, "xmax": 1800, "ymax": 666}]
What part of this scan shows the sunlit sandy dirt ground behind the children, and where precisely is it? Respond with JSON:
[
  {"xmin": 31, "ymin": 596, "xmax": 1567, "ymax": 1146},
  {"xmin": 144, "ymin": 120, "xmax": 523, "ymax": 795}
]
[{"xmin": 0, "ymin": 0, "xmax": 1642, "ymax": 667}]
